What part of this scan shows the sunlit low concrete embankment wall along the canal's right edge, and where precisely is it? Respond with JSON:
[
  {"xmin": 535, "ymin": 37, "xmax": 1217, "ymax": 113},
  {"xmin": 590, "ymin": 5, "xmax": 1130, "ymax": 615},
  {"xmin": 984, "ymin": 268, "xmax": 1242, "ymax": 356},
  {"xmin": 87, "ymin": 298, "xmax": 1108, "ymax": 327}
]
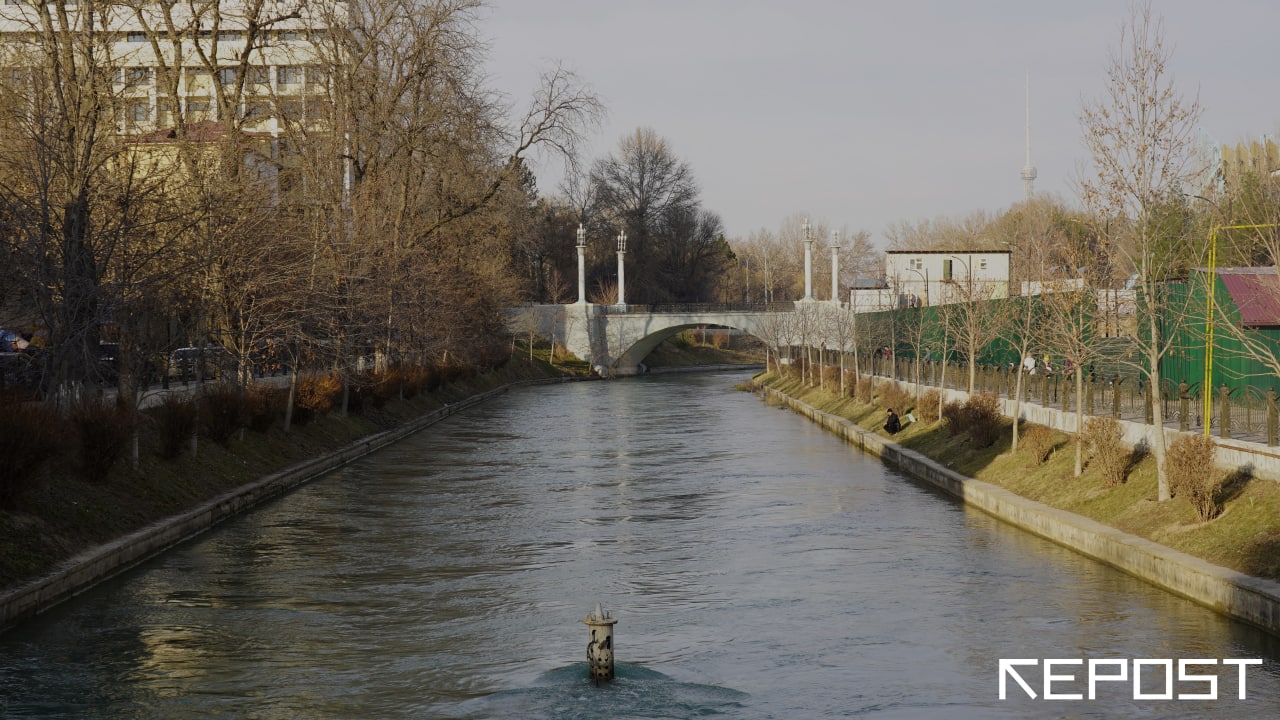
[{"xmin": 764, "ymin": 388, "xmax": 1280, "ymax": 635}]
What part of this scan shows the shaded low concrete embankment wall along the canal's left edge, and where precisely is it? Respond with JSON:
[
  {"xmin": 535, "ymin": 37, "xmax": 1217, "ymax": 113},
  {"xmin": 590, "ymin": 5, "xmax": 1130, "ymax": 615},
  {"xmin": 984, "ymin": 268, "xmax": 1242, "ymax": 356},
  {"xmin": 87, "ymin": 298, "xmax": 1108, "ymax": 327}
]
[{"xmin": 0, "ymin": 378, "xmax": 581, "ymax": 630}]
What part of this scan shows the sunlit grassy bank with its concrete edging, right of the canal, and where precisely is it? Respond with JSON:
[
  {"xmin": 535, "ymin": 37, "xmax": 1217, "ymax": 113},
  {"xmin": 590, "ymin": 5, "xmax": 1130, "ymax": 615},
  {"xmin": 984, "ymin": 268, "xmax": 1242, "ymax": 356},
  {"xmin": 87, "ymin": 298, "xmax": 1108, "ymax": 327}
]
[{"xmin": 753, "ymin": 374, "xmax": 1280, "ymax": 634}]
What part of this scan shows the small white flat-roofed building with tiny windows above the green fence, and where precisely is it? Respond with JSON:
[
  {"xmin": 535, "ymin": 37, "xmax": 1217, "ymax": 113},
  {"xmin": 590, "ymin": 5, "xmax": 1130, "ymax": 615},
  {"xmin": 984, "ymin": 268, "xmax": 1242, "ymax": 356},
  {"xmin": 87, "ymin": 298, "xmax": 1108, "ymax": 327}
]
[{"xmin": 884, "ymin": 250, "xmax": 1010, "ymax": 306}]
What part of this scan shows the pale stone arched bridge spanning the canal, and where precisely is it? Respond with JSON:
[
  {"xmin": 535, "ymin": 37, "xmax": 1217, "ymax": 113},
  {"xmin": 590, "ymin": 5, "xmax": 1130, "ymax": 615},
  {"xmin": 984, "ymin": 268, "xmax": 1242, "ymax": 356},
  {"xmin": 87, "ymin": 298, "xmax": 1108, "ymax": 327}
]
[{"xmin": 507, "ymin": 302, "xmax": 814, "ymax": 375}]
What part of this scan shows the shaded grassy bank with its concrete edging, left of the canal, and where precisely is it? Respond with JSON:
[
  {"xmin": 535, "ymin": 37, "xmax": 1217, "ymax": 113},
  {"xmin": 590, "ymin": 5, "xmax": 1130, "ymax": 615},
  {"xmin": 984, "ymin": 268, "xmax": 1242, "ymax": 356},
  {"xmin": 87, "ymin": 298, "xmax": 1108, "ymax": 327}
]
[{"xmin": 0, "ymin": 359, "xmax": 572, "ymax": 617}]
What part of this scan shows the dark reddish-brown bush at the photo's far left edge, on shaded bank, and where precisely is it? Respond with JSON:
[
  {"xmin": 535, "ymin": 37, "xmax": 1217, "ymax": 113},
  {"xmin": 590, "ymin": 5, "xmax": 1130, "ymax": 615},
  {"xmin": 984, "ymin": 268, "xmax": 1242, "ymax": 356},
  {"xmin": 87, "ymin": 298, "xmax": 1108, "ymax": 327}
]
[{"xmin": 0, "ymin": 402, "xmax": 67, "ymax": 506}]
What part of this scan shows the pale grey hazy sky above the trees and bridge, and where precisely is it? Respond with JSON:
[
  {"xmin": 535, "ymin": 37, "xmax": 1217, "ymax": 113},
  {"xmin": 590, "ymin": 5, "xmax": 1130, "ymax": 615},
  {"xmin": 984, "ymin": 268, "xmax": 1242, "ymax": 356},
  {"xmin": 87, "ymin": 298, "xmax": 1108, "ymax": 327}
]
[{"xmin": 479, "ymin": 0, "xmax": 1280, "ymax": 245}]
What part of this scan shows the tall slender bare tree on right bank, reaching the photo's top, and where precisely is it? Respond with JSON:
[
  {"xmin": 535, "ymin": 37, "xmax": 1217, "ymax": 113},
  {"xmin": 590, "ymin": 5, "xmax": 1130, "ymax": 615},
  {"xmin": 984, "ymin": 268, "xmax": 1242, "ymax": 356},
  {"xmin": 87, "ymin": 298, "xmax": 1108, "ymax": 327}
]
[{"xmin": 1080, "ymin": 1, "xmax": 1201, "ymax": 501}]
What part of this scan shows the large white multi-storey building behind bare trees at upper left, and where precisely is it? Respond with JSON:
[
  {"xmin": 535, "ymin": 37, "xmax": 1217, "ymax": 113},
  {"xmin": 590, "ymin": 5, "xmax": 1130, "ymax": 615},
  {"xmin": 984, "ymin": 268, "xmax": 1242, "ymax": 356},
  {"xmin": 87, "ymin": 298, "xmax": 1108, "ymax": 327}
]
[{"xmin": 0, "ymin": 0, "xmax": 346, "ymax": 137}]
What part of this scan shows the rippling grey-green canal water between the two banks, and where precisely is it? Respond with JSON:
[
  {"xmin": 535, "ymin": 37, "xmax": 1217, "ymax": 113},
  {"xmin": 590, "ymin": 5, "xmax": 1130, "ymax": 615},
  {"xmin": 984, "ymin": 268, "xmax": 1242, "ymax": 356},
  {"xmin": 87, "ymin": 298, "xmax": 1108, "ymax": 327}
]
[{"xmin": 0, "ymin": 373, "xmax": 1280, "ymax": 720}]
